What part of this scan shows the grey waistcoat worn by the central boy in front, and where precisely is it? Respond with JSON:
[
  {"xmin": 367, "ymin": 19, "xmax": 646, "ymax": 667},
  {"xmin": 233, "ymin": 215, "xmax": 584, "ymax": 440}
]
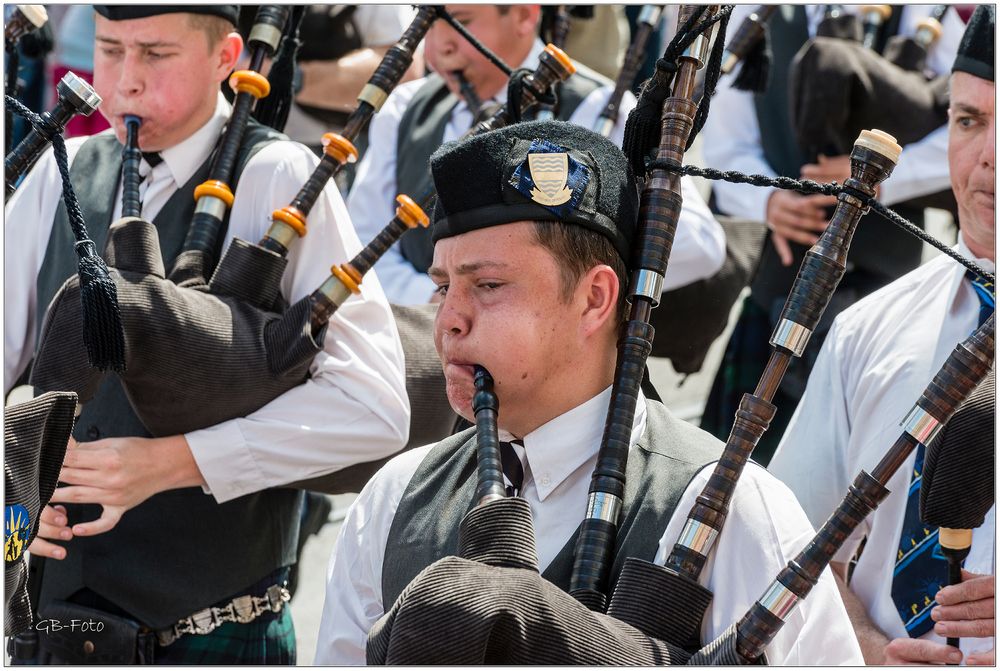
[{"xmin": 382, "ymin": 401, "xmax": 723, "ymax": 611}]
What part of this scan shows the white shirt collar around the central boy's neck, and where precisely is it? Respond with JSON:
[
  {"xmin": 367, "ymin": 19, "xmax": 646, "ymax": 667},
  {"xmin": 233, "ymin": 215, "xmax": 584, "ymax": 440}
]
[{"xmin": 500, "ymin": 387, "xmax": 646, "ymax": 501}]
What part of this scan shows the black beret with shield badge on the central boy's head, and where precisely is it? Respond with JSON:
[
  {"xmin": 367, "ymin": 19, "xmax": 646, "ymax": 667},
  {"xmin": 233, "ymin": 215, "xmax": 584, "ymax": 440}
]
[{"xmin": 431, "ymin": 121, "xmax": 639, "ymax": 264}]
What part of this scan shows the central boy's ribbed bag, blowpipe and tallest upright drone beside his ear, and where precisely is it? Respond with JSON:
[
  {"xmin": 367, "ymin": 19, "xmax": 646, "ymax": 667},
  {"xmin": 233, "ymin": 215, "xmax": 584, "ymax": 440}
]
[{"xmin": 368, "ymin": 6, "xmax": 744, "ymax": 664}]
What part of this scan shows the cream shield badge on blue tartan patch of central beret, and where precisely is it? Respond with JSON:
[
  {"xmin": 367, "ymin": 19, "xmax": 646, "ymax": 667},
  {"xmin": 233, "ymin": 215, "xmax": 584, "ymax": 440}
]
[{"xmin": 510, "ymin": 139, "xmax": 590, "ymax": 217}]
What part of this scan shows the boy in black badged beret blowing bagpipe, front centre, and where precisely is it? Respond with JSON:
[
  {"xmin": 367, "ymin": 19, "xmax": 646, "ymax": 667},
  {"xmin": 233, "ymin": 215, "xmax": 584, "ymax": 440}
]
[{"xmin": 316, "ymin": 122, "xmax": 861, "ymax": 664}]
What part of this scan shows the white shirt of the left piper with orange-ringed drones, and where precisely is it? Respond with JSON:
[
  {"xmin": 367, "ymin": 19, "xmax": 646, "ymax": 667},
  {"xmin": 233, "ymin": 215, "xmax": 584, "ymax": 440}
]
[{"xmin": 3, "ymin": 94, "xmax": 410, "ymax": 503}]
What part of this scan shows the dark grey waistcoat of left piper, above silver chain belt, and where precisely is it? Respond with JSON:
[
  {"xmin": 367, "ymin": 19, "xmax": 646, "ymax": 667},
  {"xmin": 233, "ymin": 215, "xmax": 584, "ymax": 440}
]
[{"xmin": 37, "ymin": 123, "xmax": 301, "ymax": 628}]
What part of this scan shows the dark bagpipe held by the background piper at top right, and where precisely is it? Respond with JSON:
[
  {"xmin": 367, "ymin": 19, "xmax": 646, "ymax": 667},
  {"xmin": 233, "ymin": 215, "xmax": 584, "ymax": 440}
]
[{"xmin": 722, "ymin": 5, "xmax": 948, "ymax": 178}]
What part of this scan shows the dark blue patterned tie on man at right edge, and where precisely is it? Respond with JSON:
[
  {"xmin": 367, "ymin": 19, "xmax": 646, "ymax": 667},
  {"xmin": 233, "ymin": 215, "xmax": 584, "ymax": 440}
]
[{"xmin": 892, "ymin": 271, "xmax": 995, "ymax": 638}]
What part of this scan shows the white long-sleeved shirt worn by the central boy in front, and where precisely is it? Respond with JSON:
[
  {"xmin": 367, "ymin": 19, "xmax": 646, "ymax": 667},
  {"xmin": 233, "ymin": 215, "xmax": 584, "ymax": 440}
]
[{"xmin": 316, "ymin": 388, "xmax": 862, "ymax": 665}]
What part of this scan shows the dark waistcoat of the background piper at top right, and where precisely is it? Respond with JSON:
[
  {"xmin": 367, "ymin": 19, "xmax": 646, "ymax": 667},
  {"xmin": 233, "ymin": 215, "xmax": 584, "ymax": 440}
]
[{"xmin": 751, "ymin": 5, "xmax": 923, "ymax": 316}]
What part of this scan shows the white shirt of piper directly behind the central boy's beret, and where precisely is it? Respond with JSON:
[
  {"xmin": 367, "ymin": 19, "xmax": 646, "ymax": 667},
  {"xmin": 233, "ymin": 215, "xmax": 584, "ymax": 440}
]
[{"xmin": 347, "ymin": 40, "xmax": 726, "ymax": 305}]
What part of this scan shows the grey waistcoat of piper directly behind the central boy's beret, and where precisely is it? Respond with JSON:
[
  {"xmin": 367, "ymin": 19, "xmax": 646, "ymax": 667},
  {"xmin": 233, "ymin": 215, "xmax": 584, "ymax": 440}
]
[{"xmin": 394, "ymin": 64, "xmax": 611, "ymax": 273}]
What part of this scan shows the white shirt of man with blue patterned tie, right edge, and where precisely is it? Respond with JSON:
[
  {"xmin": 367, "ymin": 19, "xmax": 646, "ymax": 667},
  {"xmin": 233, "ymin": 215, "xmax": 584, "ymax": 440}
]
[{"xmin": 769, "ymin": 239, "xmax": 996, "ymax": 654}]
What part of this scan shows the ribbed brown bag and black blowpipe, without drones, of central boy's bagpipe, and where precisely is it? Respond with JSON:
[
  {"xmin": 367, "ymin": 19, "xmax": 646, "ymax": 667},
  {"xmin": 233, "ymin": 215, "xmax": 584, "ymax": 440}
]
[{"xmin": 366, "ymin": 366, "xmax": 720, "ymax": 665}]
